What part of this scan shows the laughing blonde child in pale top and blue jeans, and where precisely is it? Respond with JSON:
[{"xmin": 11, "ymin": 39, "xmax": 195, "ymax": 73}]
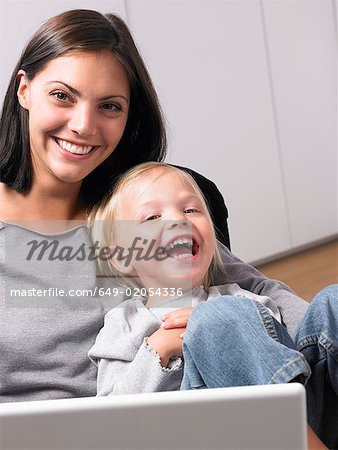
[{"xmin": 89, "ymin": 163, "xmax": 338, "ymax": 449}]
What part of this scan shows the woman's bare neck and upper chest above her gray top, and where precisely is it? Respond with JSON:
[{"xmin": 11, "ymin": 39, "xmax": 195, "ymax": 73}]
[{"xmin": 0, "ymin": 179, "xmax": 85, "ymax": 221}]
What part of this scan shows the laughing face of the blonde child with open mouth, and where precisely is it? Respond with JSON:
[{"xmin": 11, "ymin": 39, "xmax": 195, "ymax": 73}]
[{"xmin": 113, "ymin": 169, "xmax": 215, "ymax": 289}]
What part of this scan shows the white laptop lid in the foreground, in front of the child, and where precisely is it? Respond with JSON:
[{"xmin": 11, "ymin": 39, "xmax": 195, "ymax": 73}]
[{"xmin": 0, "ymin": 383, "xmax": 307, "ymax": 450}]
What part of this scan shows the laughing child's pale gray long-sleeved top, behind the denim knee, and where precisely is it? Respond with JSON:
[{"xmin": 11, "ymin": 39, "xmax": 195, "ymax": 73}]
[{"xmin": 88, "ymin": 283, "xmax": 280, "ymax": 396}]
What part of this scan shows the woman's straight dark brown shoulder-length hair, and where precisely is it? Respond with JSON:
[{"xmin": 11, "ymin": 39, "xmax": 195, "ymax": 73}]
[{"xmin": 0, "ymin": 9, "xmax": 166, "ymax": 206}]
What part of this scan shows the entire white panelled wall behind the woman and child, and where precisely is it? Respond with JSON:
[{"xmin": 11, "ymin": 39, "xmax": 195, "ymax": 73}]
[{"xmin": 0, "ymin": 0, "xmax": 338, "ymax": 261}]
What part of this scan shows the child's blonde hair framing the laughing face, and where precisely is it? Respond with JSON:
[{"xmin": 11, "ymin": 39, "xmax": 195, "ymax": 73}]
[{"xmin": 88, "ymin": 162, "xmax": 224, "ymax": 288}]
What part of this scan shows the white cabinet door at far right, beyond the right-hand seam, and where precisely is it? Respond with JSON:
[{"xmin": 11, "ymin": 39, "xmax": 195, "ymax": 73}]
[{"xmin": 263, "ymin": 0, "xmax": 338, "ymax": 247}]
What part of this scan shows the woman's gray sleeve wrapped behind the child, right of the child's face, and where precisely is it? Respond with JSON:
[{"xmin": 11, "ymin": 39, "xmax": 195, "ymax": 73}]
[{"xmin": 214, "ymin": 243, "xmax": 309, "ymax": 336}]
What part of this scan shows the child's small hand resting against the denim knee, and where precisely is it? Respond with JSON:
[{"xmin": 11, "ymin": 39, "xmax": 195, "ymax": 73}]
[{"xmin": 147, "ymin": 328, "xmax": 184, "ymax": 367}]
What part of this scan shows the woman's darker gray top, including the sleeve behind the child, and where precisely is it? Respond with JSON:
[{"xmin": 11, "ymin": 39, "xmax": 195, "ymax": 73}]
[{"xmin": 0, "ymin": 222, "xmax": 307, "ymax": 402}]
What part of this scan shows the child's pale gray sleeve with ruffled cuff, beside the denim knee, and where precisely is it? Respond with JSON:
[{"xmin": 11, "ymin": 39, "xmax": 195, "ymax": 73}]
[{"xmin": 88, "ymin": 308, "xmax": 183, "ymax": 396}]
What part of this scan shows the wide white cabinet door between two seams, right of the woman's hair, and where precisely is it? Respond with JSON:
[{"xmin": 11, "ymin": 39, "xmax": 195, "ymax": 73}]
[{"xmin": 127, "ymin": 0, "xmax": 290, "ymax": 261}]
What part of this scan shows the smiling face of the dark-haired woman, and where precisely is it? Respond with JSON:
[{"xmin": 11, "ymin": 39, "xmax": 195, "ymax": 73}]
[{"xmin": 18, "ymin": 51, "xmax": 130, "ymax": 189}]
